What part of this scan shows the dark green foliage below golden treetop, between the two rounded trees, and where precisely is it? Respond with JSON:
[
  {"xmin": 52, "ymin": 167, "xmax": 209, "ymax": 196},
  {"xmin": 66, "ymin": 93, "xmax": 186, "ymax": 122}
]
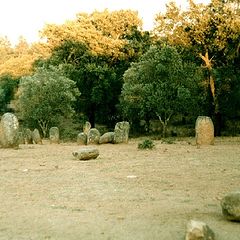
[{"xmin": 38, "ymin": 35, "xmax": 150, "ymax": 126}]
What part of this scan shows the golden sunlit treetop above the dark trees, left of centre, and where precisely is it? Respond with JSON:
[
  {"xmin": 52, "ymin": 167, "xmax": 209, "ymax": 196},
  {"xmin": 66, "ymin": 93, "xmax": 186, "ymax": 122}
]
[{"xmin": 41, "ymin": 10, "xmax": 142, "ymax": 58}]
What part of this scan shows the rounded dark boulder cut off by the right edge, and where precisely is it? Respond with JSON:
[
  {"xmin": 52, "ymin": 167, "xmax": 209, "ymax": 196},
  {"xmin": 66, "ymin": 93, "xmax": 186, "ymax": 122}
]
[{"xmin": 221, "ymin": 191, "xmax": 240, "ymax": 222}]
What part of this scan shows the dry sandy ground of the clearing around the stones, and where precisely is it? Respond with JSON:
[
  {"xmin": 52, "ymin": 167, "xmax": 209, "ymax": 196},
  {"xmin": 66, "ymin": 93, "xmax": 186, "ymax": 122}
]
[{"xmin": 0, "ymin": 138, "xmax": 240, "ymax": 240}]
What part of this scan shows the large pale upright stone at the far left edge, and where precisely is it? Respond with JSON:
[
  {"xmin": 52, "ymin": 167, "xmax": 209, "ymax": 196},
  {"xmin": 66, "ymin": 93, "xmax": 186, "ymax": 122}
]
[{"xmin": 0, "ymin": 113, "xmax": 19, "ymax": 148}]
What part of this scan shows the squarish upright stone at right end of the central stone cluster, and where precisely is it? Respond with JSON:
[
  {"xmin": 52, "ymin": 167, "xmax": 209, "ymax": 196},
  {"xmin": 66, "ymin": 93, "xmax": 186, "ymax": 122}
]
[{"xmin": 114, "ymin": 122, "xmax": 130, "ymax": 143}]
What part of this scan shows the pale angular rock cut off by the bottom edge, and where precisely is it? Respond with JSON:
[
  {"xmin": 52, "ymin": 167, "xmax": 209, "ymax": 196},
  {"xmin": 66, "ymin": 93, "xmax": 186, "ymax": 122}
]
[{"xmin": 185, "ymin": 220, "xmax": 215, "ymax": 240}]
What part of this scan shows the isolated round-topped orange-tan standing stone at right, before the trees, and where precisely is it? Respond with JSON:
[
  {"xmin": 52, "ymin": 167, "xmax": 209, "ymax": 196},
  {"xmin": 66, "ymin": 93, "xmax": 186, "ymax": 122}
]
[{"xmin": 195, "ymin": 116, "xmax": 214, "ymax": 145}]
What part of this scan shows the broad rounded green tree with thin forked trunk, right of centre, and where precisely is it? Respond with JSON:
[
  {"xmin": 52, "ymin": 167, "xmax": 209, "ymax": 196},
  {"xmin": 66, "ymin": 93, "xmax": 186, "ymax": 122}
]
[{"xmin": 122, "ymin": 46, "xmax": 203, "ymax": 137}]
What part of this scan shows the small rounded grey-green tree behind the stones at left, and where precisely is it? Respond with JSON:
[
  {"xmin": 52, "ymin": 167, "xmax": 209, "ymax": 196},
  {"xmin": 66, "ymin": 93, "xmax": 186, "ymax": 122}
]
[{"xmin": 16, "ymin": 67, "xmax": 79, "ymax": 137}]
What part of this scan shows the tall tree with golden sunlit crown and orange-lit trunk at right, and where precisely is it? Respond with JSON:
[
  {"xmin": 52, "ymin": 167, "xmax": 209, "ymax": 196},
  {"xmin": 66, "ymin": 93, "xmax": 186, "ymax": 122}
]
[{"xmin": 154, "ymin": 0, "xmax": 240, "ymax": 135}]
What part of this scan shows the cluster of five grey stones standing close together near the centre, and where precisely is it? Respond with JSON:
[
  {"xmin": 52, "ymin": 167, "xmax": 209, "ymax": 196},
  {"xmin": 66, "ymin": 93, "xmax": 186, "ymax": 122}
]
[{"xmin": 77, "ymin": 122, "xmax": 130, "ymax": 145}]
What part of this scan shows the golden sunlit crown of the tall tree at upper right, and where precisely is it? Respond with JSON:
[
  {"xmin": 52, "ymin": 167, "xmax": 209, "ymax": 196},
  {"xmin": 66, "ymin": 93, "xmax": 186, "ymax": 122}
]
[{"xmin": 154, "ymin": 0, "xmax": 240, "ymax": 56}]
